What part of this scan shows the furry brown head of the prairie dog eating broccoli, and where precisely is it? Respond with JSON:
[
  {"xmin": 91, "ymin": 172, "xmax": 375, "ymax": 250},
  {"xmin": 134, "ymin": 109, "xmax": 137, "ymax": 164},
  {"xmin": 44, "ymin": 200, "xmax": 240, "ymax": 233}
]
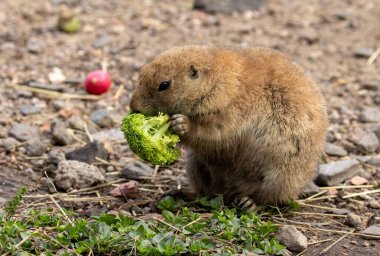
[{"xmin": 130, "ymin": 46, "xmax": 236, "ymax": 116}]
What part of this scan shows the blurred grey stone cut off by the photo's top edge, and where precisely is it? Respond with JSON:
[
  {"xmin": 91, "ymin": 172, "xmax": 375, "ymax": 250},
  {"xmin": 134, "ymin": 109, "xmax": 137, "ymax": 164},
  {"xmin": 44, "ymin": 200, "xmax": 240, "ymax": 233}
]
[{"xmin": 193, "ymin": 0, "xmax": 265, "ymax": 13}]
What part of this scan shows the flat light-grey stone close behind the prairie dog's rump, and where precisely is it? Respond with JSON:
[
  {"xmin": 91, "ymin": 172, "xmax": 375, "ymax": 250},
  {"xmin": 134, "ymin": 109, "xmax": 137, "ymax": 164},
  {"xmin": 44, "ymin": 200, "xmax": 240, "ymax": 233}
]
[{"xmin": 315, "ymin": 159, "xmax": 361, "ymax": 186}]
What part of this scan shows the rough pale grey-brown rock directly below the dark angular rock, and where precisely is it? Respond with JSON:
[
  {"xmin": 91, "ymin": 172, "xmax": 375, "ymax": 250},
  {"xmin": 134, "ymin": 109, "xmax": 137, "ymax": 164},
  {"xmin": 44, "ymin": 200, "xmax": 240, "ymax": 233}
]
[{"xmin": 55, "ymin": 160, "xmax": 106, "ymax": 191}]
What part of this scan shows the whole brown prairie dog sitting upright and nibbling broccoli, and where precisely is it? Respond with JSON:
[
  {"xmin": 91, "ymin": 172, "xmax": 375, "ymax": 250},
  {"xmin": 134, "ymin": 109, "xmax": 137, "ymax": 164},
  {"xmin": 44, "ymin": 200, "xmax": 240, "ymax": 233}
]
[{"xmin": 130, "ymin": 46, "xmax": 327, "ymax": 204}]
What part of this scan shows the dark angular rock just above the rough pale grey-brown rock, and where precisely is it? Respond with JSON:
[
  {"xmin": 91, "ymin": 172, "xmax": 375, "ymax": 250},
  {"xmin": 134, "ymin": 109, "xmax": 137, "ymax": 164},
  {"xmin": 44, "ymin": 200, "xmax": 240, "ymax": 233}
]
[{"xmin": 66, "ymin": 141, "xmax": 108, "ymax": 164}]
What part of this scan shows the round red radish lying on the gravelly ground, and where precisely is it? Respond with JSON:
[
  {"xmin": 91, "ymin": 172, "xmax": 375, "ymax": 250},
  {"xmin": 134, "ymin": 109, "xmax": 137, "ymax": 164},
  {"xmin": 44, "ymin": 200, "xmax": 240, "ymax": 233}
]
[{"xmin": 84, "ymin": 70, "xmax": 112, "ymax": 95}]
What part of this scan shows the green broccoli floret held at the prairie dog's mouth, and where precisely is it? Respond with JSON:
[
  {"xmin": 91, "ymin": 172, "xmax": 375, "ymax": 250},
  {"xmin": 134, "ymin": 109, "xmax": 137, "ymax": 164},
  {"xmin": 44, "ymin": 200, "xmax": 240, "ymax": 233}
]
[{"xmin": 121, "ymin": 113, "xmax": 181, "ymax": 165}]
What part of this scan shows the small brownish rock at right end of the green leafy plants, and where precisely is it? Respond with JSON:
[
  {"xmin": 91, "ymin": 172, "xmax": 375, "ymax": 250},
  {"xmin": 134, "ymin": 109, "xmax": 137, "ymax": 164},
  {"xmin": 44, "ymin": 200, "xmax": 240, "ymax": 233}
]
[{"xmin": 275, "ymin": 225, "xmax": 307, "ymax": 252}]
